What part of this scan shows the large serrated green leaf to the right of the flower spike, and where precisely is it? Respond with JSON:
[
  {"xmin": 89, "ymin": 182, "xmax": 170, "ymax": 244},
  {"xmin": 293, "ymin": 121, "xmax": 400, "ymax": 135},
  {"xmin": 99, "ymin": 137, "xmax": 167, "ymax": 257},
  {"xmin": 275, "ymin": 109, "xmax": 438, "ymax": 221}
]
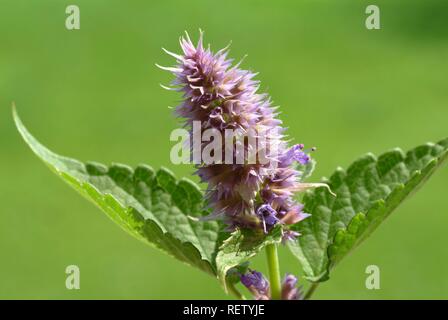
[{"xmin": 289, "ymin": 139, "xmax": 448, "ymax": 282}]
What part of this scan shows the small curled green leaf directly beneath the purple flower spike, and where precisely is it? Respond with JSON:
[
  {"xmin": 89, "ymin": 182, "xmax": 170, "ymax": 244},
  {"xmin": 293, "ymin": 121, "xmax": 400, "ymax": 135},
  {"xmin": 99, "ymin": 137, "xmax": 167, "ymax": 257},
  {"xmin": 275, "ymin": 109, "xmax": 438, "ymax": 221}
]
[{"xmin": 216, "ymin": 225, "xmax": 282, "ymax": 288}]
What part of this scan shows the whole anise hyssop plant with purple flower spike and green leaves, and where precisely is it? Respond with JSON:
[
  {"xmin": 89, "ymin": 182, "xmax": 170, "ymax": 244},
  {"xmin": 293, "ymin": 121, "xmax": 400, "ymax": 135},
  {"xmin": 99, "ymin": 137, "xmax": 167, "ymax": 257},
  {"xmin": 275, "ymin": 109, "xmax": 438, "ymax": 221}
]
[{"xmin": 13, "ymin": 33, "xmax": 448, "ymax": 300}]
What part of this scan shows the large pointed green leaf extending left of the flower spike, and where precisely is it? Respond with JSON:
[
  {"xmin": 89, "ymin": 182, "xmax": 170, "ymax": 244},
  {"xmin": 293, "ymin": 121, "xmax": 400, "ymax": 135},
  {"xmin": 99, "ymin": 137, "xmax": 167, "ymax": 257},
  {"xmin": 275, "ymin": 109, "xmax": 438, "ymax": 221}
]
[{"xmin": 13, "ymin": 109, "xmax": 221, "ymax": 275}]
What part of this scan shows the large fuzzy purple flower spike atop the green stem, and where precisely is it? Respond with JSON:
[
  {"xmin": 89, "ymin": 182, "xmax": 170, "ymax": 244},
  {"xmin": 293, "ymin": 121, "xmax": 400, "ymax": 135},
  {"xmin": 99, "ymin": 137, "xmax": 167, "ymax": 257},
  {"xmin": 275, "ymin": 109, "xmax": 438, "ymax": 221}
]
[{"xmin": 161, "ymin": 32, "xmax": 318, "ymax": 232}]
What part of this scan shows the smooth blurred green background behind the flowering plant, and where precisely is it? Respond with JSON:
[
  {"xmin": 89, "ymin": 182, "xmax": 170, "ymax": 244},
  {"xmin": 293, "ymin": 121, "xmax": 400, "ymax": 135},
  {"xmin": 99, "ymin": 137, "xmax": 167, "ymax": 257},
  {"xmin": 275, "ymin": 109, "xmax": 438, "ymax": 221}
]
[{"xmin": 0, "ymin": 0, "xmax": 448, "ymax": 299}]
